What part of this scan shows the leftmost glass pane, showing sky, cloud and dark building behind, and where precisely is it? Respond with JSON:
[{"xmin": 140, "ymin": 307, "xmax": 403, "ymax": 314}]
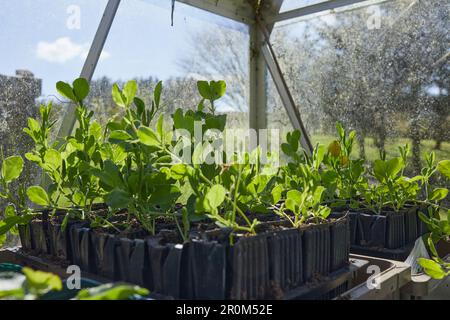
[{"xmin": 0, "ymin": 0, "xmax": 106, "ymax": 245}]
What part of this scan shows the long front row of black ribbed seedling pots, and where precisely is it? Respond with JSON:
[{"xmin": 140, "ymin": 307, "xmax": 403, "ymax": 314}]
[{"xmin": 20, "ymin": 216, "xmax": 350, "ymax": 299}]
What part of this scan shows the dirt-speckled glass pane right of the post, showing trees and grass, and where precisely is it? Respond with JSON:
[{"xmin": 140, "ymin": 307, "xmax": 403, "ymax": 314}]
[{"xmin": 271, "ymin": 0, "xmax": 450, "ymax": 172}]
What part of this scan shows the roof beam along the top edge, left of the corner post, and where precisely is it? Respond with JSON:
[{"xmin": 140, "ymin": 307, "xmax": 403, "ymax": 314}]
[{"xmin": 175, "ymin": 0, "xmax": 255, "ymax": 24}]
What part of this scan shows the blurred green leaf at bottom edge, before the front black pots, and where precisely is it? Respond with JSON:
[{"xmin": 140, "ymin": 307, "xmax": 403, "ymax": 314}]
[{"xmin": 75, "ymin": 283, "xmax": 149, "ymax": 300}]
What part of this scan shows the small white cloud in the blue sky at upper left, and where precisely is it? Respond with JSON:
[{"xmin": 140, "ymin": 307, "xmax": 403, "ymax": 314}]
[{"xmin": 36, "ymin": 37, "xmax": 111, "ymax": 64}]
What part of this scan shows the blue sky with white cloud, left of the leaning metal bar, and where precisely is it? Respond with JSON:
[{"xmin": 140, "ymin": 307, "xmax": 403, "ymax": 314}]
[{"xmin": 0, "ymin": 0, "xmax": 107, "ymax": 99}]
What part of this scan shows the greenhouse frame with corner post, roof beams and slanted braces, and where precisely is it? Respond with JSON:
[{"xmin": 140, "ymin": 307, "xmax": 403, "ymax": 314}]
[{"xmin": 60, "ymin": 0, "xmax": 394, "ymax": 155}]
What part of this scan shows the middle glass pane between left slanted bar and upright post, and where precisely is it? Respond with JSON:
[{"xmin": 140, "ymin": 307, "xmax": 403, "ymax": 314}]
[{"xmin": 91, "ymin": 0, "xmax": 249, "ymax": 128}]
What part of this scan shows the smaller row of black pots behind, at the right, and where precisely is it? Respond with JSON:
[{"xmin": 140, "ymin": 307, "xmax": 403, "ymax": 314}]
[{"xmin": 331, "ymin": 206, "xmax": 427, "ymax": 249}]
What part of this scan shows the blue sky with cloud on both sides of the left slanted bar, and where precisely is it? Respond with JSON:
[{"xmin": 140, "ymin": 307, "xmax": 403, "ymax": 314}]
[{"xmin": 0, "ymin": 0, "xmax": 245, "ymax": 96}]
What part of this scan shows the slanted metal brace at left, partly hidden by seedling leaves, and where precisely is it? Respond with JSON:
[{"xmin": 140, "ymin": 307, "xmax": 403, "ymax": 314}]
[{"xmin": 58, "ymin": 0, "xmax": 120, "ymax": 137}]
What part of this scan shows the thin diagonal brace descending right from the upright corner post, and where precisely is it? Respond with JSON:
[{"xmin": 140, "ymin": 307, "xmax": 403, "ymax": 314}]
[{"xmin": 258, "ymin": 20, "xmax": 313, "ymax": 154}]
